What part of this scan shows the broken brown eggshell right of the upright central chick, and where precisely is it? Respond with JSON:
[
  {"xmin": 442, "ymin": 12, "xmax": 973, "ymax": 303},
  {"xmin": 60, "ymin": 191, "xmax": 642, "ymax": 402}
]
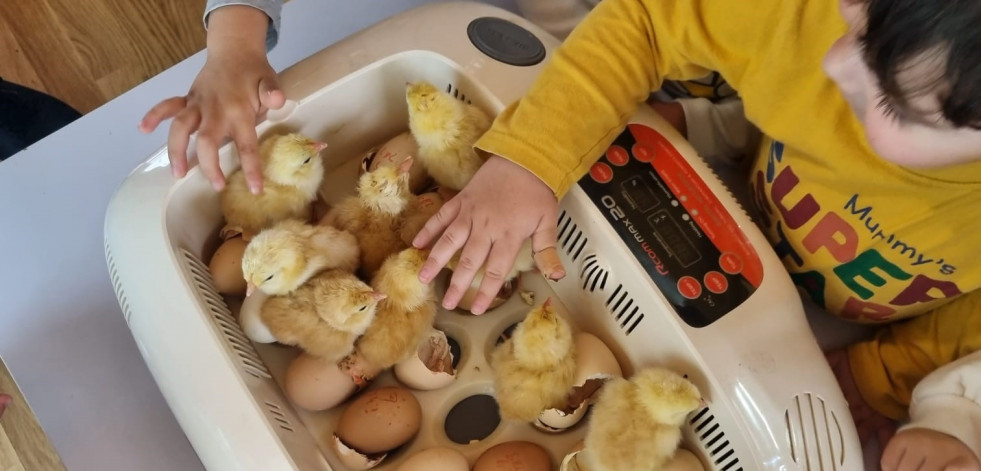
[{"xmin": 533, "ymin": 332, "xmax": 623, "ymax": 432}]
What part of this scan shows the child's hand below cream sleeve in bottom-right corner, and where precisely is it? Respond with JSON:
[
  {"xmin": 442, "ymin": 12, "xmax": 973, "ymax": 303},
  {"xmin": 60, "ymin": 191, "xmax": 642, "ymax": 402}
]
[{"xmin": 879, "ymin": 428, "xmax": 981, "ymax": 471}]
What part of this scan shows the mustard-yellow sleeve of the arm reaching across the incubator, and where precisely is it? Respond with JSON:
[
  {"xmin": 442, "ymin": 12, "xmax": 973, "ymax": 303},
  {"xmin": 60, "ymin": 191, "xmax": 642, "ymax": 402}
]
[{"xmin": 476, "ymin": 0, "xmax": 764, "ymax": 197}]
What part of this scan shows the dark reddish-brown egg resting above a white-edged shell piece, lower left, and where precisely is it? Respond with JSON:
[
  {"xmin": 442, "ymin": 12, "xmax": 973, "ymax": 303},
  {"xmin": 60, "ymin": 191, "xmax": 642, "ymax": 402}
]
[{"xmin": 334, "ymin": 387, "xmax": 422, "ymax": 454}]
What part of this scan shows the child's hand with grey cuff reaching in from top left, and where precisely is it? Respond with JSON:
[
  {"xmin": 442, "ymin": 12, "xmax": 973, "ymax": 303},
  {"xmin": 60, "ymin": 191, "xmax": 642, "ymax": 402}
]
[{"xmin": 140, "ymin": 5, "xmax": 285, "ymax": 193}]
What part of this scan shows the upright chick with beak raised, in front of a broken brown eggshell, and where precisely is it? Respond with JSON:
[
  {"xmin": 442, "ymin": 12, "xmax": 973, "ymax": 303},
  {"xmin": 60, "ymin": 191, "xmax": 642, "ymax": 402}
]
[{"xmin": 491, "ymin": 299, "xmax": 576, "ymax": 422}]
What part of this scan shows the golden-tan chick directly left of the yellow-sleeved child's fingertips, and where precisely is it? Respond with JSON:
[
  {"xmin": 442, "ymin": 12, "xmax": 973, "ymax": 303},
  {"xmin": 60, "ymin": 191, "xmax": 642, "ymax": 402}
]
[{"xmin": 356, "ymin": 248, "xmax": 436, "ymax": 369}]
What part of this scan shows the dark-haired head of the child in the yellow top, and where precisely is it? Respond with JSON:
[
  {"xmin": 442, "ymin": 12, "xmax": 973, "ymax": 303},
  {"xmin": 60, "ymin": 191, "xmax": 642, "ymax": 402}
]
[{"xmin": 824, "ymin": 0, "xmax": 981, "ymax": 167}]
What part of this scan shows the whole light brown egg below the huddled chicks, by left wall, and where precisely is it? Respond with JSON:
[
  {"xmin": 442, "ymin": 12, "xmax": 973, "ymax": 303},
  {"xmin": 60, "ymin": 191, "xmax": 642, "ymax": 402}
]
[{"xmin": 283, "ymin": 353, "xmax": 358, "ymax": 411}]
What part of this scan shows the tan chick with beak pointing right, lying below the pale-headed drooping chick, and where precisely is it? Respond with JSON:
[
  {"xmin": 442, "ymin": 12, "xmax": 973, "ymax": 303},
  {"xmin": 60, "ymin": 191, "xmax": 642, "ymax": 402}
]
[{"xmin": 260, "ymin": 270, "xmax": 385, "ymax": 362}]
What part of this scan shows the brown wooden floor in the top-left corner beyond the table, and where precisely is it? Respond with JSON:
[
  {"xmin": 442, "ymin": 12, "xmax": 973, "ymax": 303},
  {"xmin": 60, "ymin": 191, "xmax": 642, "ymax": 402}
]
[{"xmin": 0, "ymin": 0, "xmax": 205, "ymax": 113}]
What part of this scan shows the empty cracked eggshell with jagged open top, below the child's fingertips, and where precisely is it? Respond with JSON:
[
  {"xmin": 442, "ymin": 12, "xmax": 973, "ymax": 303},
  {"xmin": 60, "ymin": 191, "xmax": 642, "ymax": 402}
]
[{"xmin": 395, "ymin": 329, "xmax": 456, "ymax": 391}]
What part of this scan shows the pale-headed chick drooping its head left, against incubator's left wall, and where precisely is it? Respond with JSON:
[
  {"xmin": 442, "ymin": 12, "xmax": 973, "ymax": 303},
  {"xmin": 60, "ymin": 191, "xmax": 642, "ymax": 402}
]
[{"xmin": 242, "ymin": 219, "xmax": 361, "ymax": 295}]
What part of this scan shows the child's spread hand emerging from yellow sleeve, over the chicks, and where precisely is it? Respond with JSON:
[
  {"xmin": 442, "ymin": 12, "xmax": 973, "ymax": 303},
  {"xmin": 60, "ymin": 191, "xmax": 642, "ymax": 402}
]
[{"xmin": 412, "ymin": 155, "xmax": 565, "ymax": 314}]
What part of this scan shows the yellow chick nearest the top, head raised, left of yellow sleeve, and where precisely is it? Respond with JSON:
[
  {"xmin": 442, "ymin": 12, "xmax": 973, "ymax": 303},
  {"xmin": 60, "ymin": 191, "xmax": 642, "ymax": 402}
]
[{"xmin": 405, "ymin": 82, "xmax": 491, "ymax": 190}]
